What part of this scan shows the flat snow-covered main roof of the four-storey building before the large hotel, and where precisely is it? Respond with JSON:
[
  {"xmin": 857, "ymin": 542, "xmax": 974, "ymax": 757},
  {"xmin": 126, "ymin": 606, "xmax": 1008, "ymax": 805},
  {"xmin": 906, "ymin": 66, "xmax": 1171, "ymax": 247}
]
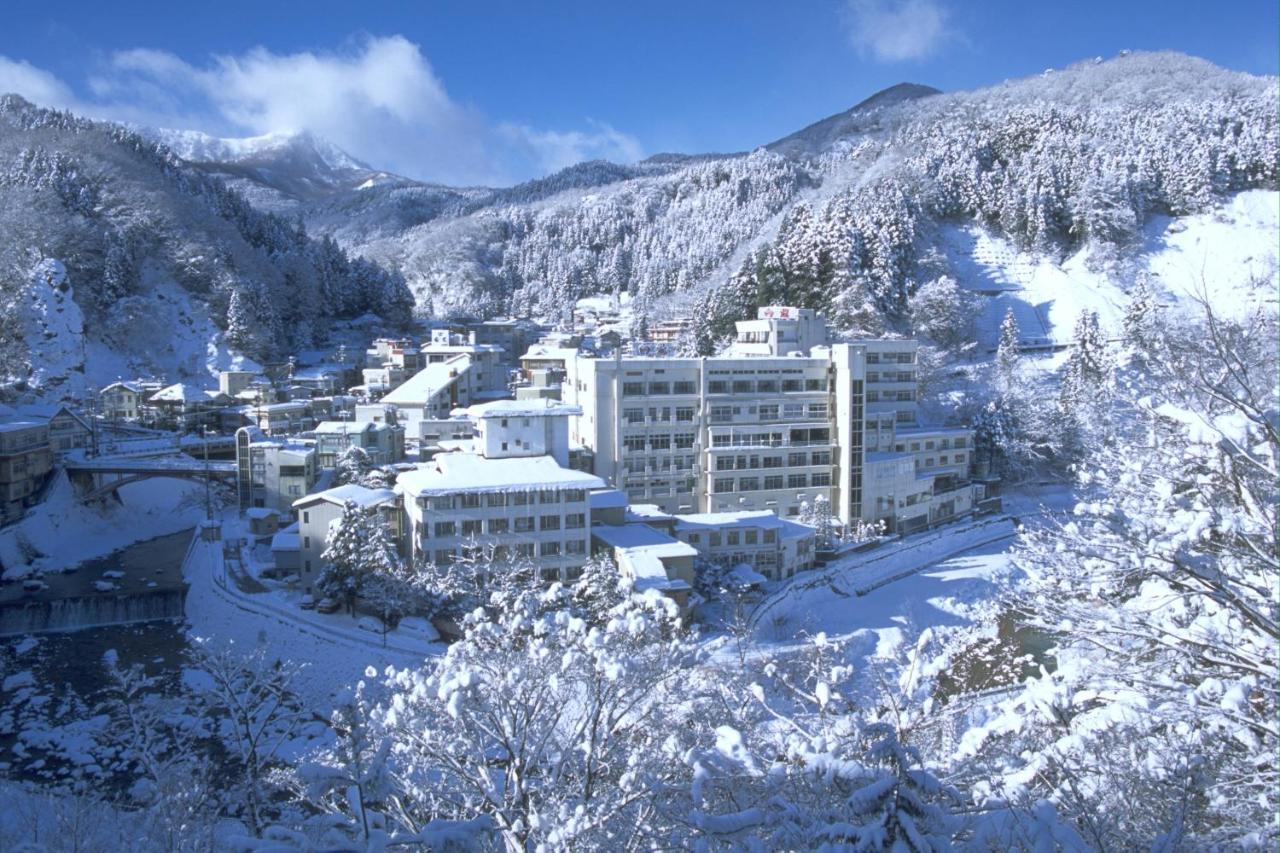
[{"xmin": 396, "ymin": 453, "xmax": 604, "ymax": 496}]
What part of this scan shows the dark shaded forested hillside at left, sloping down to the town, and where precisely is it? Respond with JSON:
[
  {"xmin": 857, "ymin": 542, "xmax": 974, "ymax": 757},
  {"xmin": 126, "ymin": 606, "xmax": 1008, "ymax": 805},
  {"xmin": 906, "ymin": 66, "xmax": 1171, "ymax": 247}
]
[{"xmin": 0, "ymin": 96, "xmax": 411, "ymax": 394}]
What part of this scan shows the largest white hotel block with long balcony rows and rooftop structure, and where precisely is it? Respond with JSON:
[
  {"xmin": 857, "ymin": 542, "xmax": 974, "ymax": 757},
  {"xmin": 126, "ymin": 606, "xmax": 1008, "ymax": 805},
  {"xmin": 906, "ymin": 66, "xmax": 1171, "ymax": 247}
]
[{"xmin": 562, "ymin": 307, "xmax": 980, "ymax": 530}]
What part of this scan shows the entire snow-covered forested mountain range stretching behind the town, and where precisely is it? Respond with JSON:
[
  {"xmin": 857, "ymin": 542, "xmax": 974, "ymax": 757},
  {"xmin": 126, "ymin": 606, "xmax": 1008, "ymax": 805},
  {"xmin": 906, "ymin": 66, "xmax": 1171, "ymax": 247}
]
[{"xmin": 0, "ymin": 54, "xmax": 1277, "ymax": 399}]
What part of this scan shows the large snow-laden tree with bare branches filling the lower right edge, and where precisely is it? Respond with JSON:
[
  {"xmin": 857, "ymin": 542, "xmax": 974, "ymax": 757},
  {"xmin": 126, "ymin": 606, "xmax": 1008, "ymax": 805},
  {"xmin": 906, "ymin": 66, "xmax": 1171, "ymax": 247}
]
[{"xmin": 961, "ymin": 298, "xmax": 1280, "ymax": 849}]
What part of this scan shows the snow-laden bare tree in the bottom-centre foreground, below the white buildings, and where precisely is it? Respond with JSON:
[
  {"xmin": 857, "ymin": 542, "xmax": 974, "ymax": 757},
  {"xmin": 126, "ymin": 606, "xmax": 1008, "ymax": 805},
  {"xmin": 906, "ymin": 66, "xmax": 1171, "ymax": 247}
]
[{"xmin": 293, "ymin": 585, "xmax": 692, "ymax": 849}]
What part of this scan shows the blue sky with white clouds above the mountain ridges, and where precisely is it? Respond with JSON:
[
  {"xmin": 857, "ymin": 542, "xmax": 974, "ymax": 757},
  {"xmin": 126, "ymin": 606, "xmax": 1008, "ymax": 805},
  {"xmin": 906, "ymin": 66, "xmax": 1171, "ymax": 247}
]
[{"xmin": 0, "ymin": 0, "xmax": 1280, "ymax": 183}]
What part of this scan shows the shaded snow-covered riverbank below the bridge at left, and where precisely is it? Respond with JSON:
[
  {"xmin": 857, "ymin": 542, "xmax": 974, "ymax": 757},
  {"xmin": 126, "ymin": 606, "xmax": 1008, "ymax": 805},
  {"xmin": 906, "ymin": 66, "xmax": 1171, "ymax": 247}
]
[{"xmin": 0, "ymin": 473, "xmax": 205, "ymax": 579}]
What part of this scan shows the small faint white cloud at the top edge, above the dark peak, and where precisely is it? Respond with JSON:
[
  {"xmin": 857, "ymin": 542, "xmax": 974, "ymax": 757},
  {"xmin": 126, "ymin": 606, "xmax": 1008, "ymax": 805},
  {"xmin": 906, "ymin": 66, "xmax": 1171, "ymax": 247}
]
[{"xmin": 846, "ymin": 0, "xmax": 956, "ymax": 63}]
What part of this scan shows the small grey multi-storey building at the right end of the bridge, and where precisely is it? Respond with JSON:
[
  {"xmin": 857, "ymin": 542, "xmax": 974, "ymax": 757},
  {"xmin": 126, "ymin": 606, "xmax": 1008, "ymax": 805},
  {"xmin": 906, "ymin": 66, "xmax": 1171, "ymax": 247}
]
[{"xmin": 236, "ymin": 427, "xmax": 319, "ymax": 514}]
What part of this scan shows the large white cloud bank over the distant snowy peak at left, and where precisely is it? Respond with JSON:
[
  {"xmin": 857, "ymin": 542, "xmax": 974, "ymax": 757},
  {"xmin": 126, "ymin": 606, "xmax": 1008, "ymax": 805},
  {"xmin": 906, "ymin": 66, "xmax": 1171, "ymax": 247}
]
[{"xmin": 0, "ymin": 36, "xmax": 643, "ymax": 183}]
